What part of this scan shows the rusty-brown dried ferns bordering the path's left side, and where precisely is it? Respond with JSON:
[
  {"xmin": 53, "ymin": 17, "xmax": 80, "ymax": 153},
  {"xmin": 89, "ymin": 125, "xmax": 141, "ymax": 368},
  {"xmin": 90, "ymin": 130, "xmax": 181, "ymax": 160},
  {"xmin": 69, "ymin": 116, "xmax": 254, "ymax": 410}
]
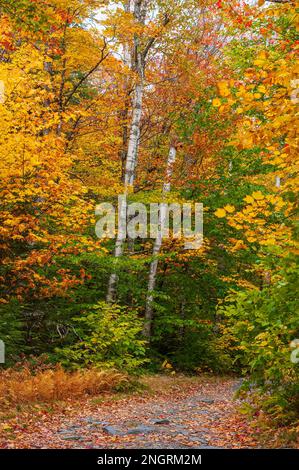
[{"xmin": 0, "ymin": 366, "xmax": 127, "ymax": 407}]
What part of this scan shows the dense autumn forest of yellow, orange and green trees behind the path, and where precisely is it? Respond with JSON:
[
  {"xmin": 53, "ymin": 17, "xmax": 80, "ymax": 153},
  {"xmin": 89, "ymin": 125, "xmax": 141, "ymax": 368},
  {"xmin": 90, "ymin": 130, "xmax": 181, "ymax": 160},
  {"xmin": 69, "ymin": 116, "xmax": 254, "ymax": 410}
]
[{"xmin": 0, "ymin": 0, "xmax": 299, "ymax": 434}]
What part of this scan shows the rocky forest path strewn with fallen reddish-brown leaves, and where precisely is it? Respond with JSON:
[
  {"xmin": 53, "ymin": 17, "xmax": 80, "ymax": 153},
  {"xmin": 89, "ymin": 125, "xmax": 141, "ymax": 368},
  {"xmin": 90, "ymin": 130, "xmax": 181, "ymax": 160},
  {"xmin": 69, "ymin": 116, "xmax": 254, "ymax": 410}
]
[{"xmin": 0, "ymin": 377, "xmax": 258, "ymax": 449}]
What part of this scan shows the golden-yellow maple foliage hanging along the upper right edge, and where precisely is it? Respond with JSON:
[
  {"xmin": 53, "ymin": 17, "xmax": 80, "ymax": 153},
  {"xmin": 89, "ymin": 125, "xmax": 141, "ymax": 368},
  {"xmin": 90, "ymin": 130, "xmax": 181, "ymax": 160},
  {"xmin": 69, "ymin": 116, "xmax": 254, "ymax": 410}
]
[{"xmin": 214, "ymin": 2, "xmax": 299, "ymax": 258}]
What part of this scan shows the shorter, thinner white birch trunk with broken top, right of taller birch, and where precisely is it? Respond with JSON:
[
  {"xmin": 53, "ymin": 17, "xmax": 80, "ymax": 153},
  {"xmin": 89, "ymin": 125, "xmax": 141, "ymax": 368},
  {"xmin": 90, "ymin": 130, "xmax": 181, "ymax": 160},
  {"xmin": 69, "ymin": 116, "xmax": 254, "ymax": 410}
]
[{"xmin": 143, "ymin": 145, "xmax": 177, "ymax": 340}]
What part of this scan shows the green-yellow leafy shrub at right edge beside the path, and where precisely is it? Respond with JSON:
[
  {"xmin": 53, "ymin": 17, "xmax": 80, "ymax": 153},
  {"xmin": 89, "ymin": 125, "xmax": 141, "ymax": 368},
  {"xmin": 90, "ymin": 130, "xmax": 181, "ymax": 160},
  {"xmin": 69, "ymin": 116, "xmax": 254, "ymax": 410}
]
[{"xmin": 218, "ymin": 268, "xmax": 299, "ymax": 425}]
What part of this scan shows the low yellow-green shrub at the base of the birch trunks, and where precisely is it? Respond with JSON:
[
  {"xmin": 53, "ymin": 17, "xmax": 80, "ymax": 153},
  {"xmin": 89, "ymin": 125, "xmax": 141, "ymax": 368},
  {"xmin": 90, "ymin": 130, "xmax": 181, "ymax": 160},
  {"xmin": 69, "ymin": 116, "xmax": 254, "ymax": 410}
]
[{"xmin": 56, "ymin": 302, "xmax": 147, "ymax": 373}]
